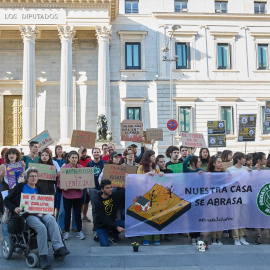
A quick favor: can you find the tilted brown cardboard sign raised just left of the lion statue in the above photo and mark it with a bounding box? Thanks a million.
[71,130,97,149]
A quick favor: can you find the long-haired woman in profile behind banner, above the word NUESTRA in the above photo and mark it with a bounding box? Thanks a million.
[207,156,225,245]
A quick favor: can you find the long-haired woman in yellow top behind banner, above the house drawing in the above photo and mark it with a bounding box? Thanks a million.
[137,150,164,246]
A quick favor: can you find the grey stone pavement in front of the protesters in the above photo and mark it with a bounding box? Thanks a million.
[0,210,270,270]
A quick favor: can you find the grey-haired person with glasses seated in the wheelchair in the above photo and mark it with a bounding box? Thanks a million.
[4,167,70,269]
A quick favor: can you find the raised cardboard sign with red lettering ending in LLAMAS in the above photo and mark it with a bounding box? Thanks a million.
[121,120,143,142]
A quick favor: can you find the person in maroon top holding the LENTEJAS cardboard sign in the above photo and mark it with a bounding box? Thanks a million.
[58,151,85,240]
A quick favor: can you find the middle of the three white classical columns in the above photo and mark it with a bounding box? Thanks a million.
[58,26,75,145]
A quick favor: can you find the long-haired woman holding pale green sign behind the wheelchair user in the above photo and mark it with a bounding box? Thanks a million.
[38,148,56,195]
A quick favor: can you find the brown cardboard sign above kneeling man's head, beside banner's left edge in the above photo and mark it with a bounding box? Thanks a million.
[102,164,138,187]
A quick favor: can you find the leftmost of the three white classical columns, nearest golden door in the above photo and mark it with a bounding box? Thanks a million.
[20,25,37,145]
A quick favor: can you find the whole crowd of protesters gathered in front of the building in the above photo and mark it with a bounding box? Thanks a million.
[0,141,270,266]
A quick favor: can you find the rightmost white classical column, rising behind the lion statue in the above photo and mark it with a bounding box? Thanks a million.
[96,26,111,130]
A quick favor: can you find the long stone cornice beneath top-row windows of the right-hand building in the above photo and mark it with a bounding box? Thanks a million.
[152,12,270,21]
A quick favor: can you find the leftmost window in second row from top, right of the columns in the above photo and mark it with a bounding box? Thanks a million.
[125,42,141,69]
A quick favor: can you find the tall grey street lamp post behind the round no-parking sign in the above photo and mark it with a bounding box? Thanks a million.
[162,24,181,145]
